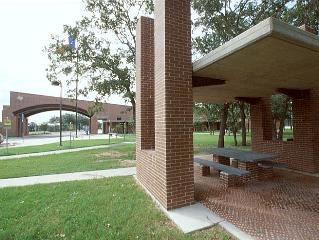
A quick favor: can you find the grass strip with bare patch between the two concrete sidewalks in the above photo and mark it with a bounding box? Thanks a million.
[0,144,135,179]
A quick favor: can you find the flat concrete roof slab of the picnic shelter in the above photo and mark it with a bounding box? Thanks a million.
[193,18,319,103]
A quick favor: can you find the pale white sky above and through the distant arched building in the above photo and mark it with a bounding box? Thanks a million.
[0,0,125,123]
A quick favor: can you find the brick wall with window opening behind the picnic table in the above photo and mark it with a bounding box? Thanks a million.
[251,89,319,173]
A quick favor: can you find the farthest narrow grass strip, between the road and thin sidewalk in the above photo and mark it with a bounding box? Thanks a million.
[0,135,135,156]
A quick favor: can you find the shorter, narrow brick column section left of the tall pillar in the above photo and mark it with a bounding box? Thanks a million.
[136,17,155,150]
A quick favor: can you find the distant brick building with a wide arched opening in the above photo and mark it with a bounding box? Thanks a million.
[2,92,133,137]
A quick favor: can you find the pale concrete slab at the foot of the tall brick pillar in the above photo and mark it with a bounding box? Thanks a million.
[165,203,223,233]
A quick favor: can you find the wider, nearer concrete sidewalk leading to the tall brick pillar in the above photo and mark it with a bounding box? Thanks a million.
[0,167,136,188]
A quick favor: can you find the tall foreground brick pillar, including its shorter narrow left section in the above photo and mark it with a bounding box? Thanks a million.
[136,0,194,209]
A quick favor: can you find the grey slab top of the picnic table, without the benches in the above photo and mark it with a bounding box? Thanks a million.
[209,148,276,162]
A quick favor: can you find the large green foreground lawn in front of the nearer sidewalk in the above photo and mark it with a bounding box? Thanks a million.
[0,177,230,240]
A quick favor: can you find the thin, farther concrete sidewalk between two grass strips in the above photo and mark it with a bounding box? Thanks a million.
[0,142,135,161]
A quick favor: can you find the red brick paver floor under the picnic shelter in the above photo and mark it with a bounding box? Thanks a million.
[195,169,319,240]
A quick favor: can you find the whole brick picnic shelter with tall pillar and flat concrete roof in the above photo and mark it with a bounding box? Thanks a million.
[136,0,319,209]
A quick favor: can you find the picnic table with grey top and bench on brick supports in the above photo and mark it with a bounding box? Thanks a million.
[194,148,276,187]
